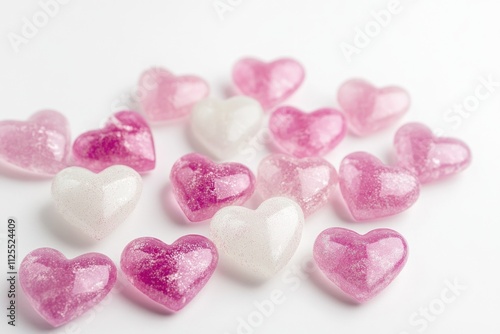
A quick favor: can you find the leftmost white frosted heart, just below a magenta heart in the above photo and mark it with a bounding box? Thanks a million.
[52,165,142,240]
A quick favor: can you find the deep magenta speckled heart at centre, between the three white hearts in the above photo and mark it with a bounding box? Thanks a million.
[170,153,255,222]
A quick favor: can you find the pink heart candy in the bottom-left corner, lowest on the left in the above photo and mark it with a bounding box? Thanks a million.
[19,248,116,327]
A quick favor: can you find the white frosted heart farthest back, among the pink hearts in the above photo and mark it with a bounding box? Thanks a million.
[191,96,264,160]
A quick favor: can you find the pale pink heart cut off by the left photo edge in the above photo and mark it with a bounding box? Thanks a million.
[0,110,71,176]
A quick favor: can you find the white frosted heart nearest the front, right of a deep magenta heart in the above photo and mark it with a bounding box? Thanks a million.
[210,197,304,279]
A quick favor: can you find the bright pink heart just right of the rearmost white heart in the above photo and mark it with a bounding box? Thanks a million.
[269,107,347,158]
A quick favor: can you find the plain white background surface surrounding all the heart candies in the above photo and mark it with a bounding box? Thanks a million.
[0,0,500,334]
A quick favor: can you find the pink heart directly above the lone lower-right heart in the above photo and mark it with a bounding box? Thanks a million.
[339,152,420,221]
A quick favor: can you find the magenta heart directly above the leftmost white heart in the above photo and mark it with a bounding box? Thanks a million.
[73,111,156,173]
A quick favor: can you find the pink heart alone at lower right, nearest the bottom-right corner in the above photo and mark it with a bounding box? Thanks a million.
[313,227,408,302]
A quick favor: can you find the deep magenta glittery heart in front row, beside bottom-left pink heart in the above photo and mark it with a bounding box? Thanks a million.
[120,235,219,312]
